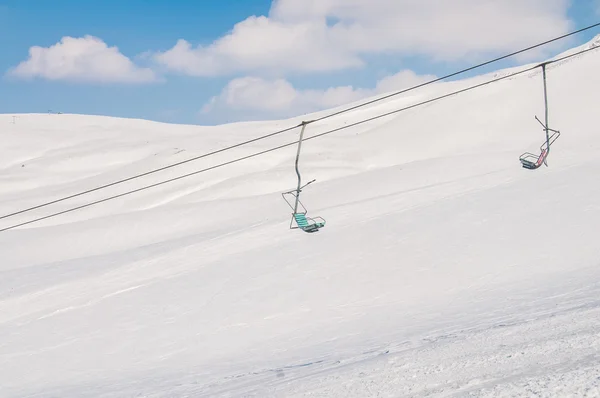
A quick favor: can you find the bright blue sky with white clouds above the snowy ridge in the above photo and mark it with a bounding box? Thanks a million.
[0,0,600,124]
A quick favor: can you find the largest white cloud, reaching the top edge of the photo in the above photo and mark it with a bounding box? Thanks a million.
[155,0,570,76]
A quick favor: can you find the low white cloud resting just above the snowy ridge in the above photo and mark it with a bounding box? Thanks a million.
[202,70,435,117]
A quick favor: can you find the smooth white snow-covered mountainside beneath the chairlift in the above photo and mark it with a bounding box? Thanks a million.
[0,40,600,397]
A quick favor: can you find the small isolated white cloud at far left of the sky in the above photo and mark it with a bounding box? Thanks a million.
[8,36,156,83]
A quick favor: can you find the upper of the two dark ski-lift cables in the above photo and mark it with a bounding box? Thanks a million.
[0,22,600,221]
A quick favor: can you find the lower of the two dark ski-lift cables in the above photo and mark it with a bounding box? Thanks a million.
[0,46,600,232]
